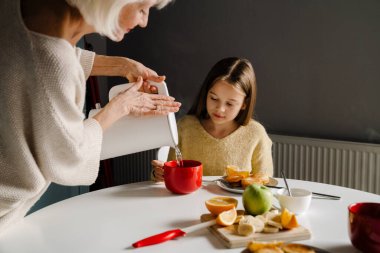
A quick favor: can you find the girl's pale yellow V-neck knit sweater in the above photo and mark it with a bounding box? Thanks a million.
[168,115,273,176]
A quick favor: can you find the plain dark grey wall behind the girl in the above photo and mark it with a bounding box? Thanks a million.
[107,0,380,143]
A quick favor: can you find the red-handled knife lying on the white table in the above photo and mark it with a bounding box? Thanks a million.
[132,220,216,248]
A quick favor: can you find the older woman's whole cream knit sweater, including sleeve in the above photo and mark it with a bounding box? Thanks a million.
[0,0,102,233]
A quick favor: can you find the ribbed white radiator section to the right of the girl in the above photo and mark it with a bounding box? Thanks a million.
[270,135,380,194]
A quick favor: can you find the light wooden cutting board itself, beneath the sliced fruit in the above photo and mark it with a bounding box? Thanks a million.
[201,212,311,248]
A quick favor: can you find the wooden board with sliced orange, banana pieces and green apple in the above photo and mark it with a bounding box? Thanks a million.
[201,196,311,249]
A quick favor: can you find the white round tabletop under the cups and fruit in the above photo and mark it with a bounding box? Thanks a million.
[0,177,380,253]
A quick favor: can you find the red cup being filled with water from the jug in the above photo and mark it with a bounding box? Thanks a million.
[164,160,203,194]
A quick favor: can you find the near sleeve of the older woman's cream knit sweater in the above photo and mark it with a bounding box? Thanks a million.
[32,51,103,185]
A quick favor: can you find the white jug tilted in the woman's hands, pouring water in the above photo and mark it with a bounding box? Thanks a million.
[89,82,178,160]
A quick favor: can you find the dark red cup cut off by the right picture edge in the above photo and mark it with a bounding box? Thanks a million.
[348,202,380,252]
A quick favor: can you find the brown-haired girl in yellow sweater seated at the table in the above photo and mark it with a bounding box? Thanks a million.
[152,57,273,181]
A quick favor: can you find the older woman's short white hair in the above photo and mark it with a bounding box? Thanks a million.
[66,0,172,41]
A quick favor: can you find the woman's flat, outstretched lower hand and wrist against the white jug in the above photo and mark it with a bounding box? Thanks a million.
[94,77,181,130]
